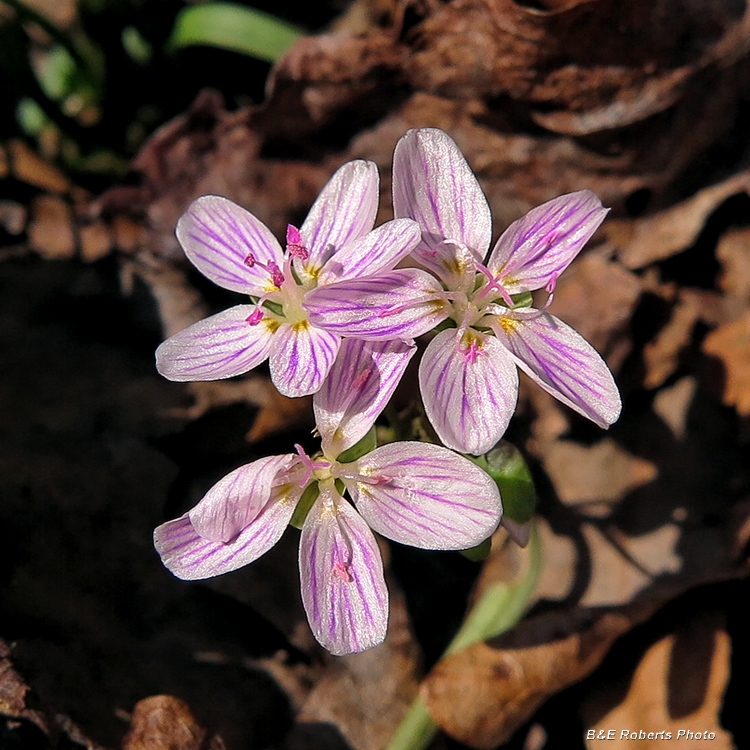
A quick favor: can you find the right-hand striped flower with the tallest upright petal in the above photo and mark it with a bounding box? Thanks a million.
[388,128,621,454]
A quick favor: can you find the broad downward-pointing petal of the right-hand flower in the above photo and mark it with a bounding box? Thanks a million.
[419,328,518,455]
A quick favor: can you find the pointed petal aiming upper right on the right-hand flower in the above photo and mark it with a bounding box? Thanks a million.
[487,190,609,294]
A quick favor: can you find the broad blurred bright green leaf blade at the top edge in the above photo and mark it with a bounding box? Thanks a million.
[169,3,304,62]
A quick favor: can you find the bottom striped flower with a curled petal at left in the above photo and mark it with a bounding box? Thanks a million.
[154,339,502,654]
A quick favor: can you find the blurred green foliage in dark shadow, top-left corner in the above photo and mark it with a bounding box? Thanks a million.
[0,0,339,190]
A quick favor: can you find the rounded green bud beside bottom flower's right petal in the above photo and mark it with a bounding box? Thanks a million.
[466,440,536,523]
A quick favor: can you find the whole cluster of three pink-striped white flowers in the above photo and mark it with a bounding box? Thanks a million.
[155,128,620,654]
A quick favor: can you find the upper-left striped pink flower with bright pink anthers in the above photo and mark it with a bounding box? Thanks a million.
[156,160,447,396]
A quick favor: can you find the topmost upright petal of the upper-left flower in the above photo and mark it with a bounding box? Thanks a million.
[302,159,380,275]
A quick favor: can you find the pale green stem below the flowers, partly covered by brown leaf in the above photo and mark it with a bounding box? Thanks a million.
[387,524,542,750]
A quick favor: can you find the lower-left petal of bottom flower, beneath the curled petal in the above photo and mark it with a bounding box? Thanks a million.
[154,476,302,581]
